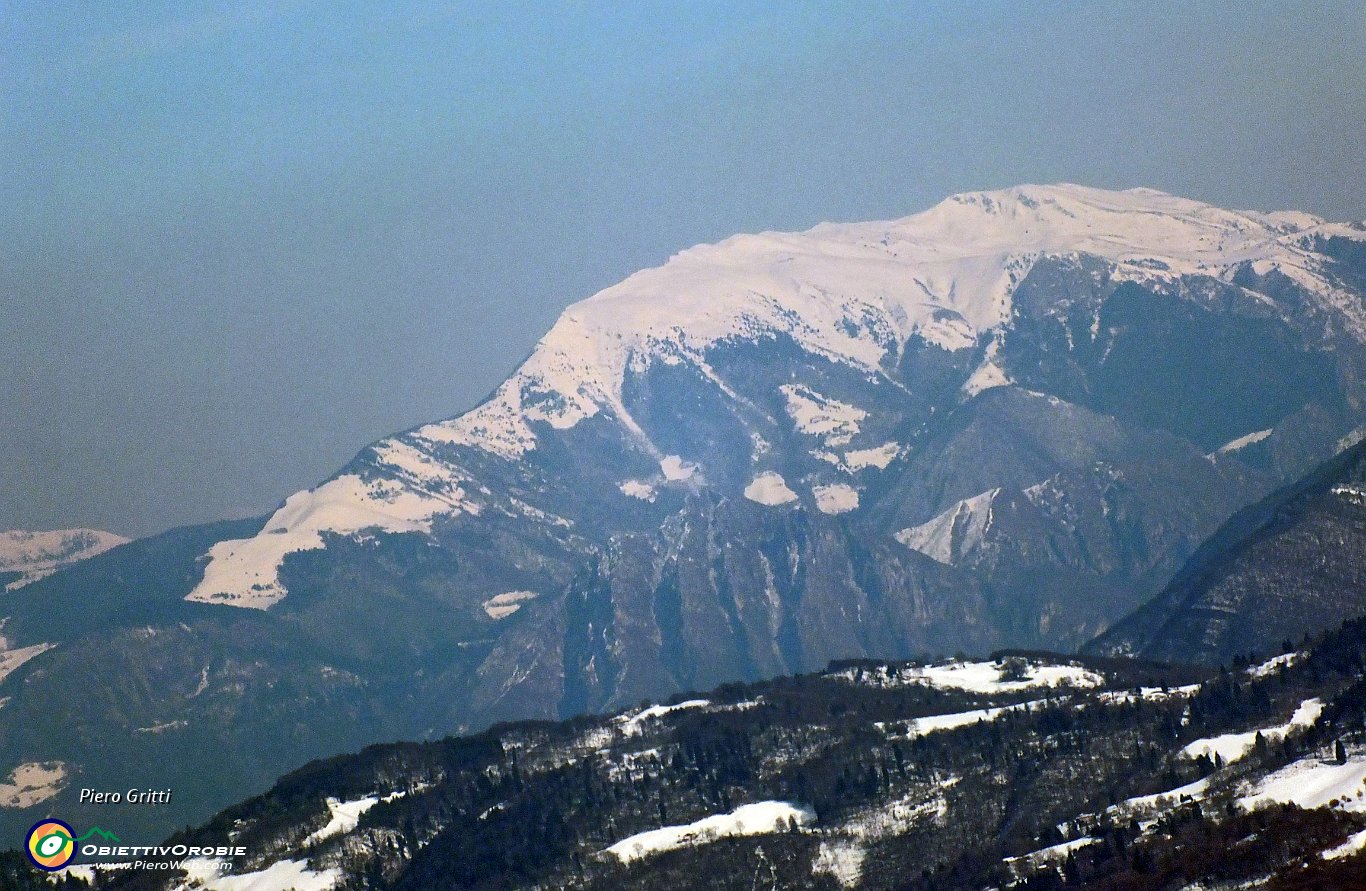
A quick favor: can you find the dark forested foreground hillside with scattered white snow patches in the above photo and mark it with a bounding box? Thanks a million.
[56,622,1366,891]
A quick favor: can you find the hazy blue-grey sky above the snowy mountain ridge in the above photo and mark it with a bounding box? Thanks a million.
[0,0,1366,534]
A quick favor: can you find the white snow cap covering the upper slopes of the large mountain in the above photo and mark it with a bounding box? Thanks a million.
[190,180,1366,608]
